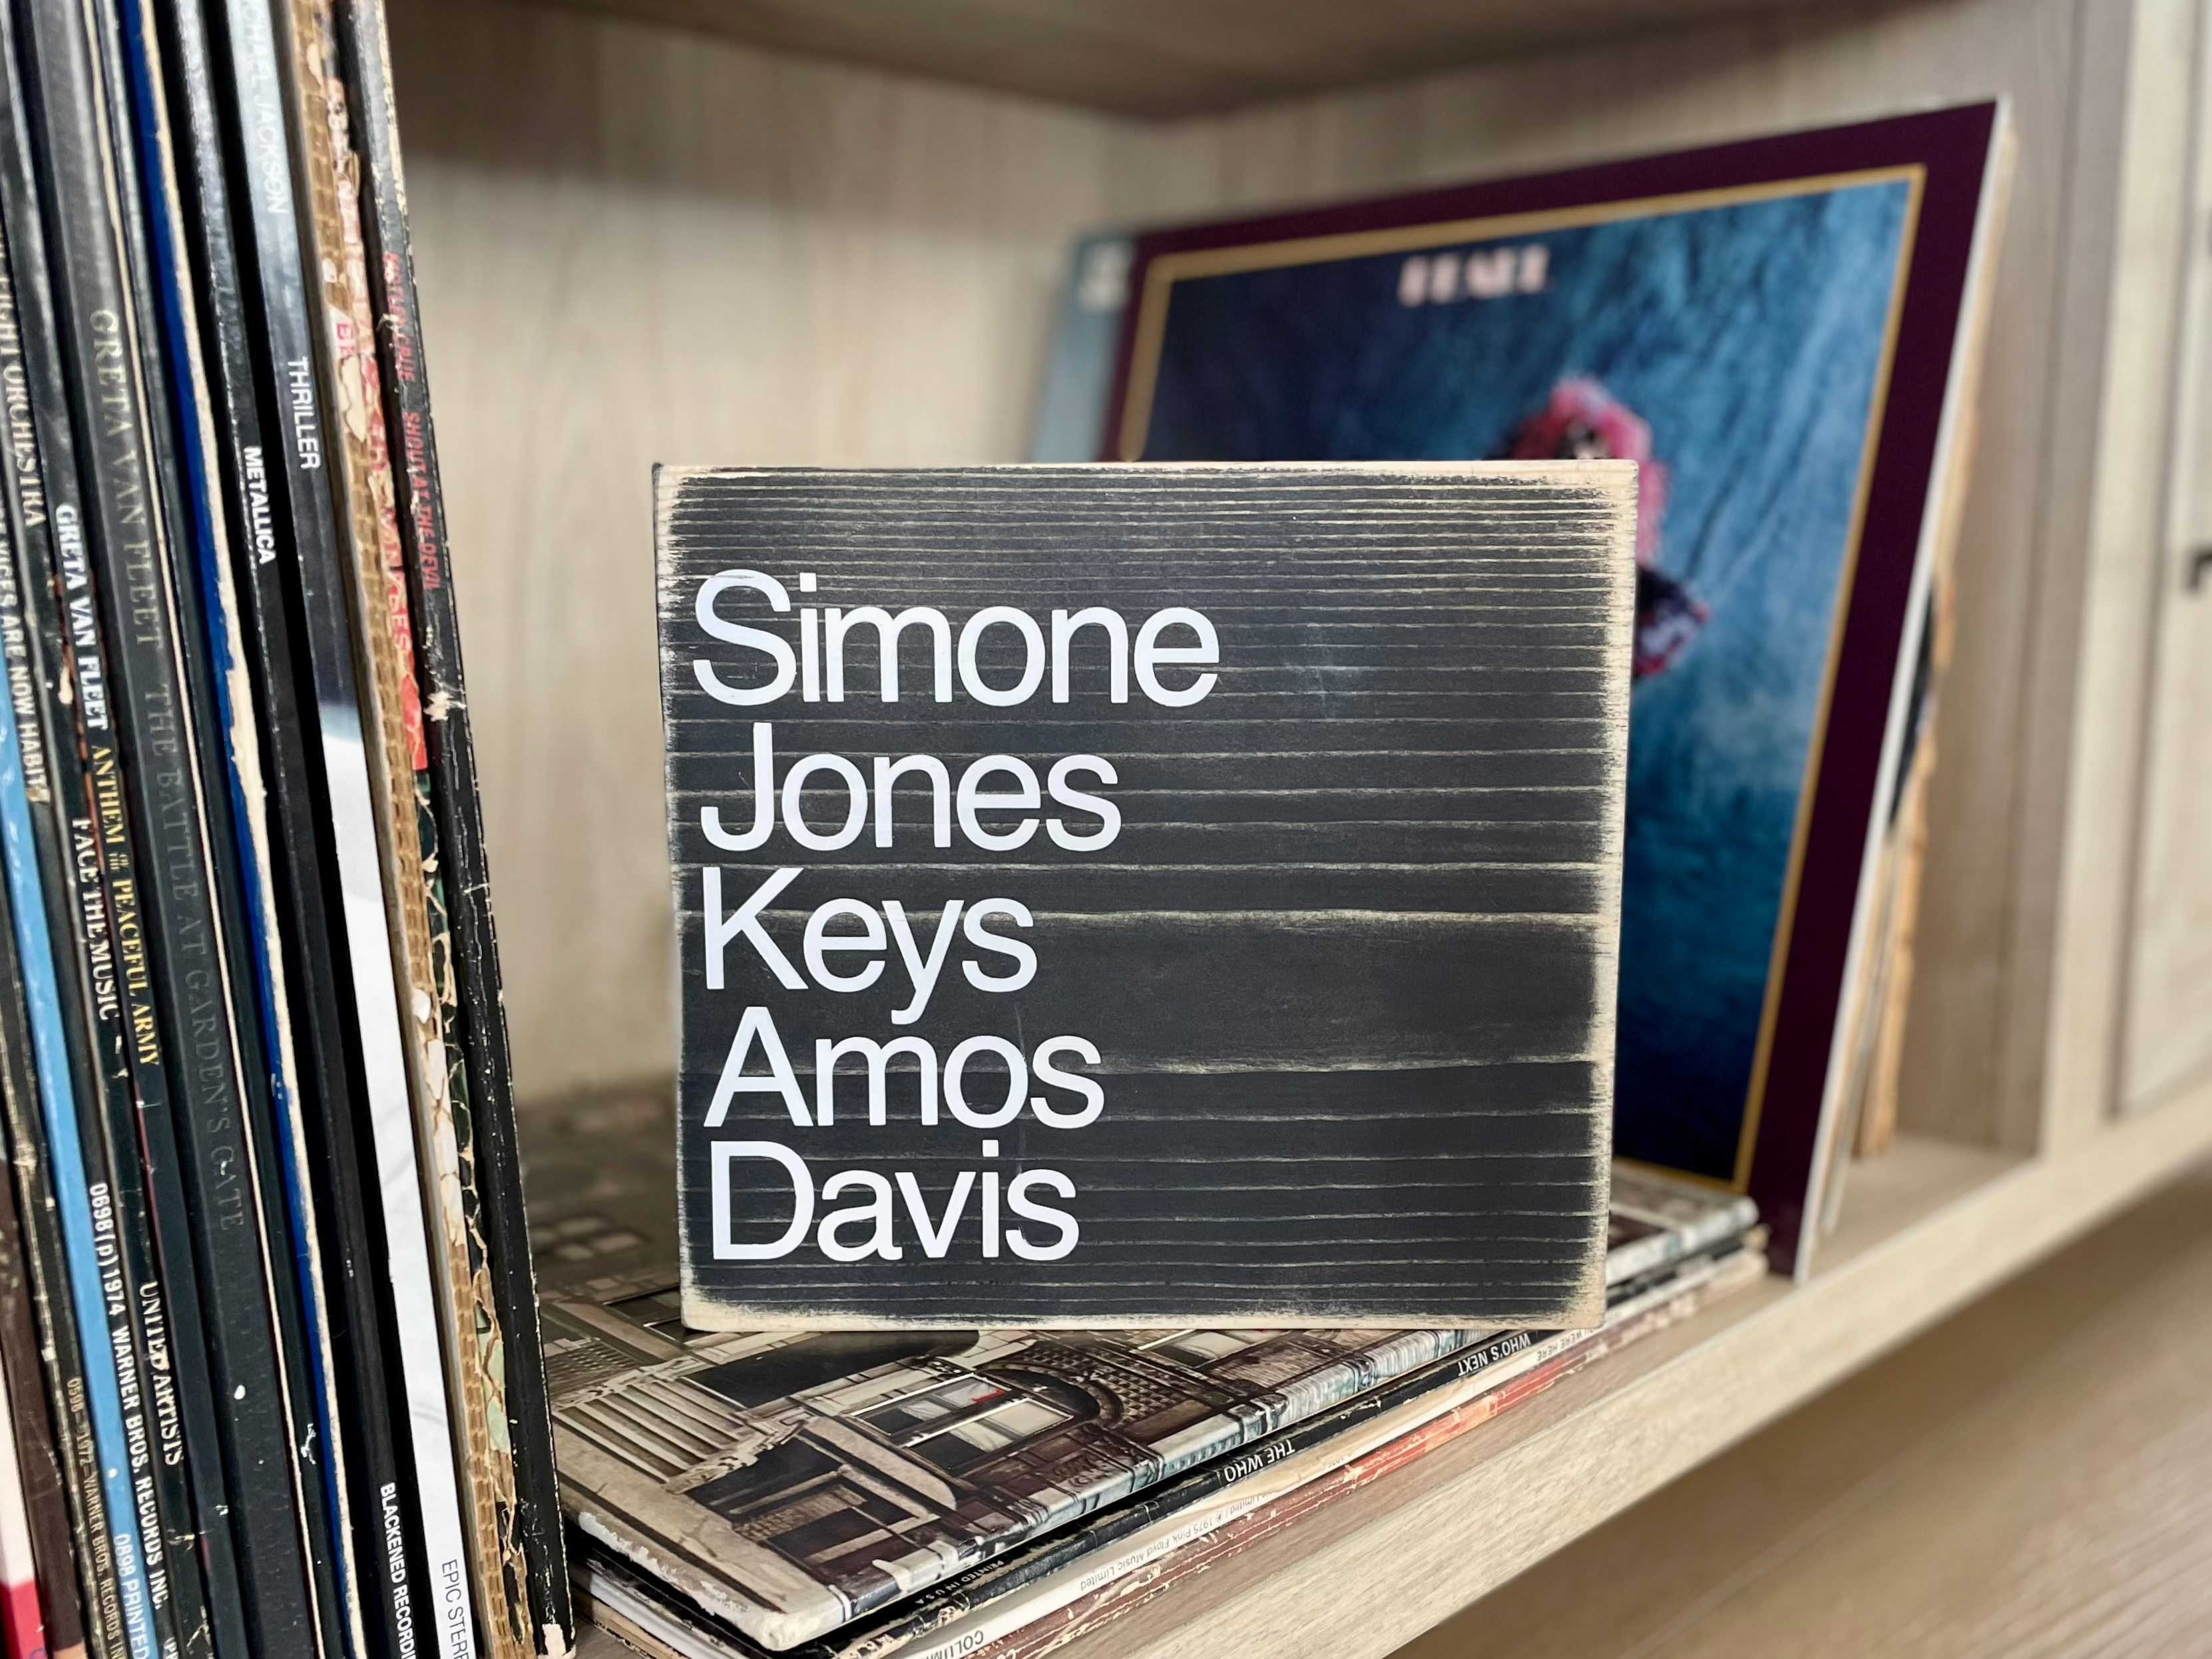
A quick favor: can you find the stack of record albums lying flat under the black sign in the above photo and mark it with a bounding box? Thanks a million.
[525,1093,1767,1659]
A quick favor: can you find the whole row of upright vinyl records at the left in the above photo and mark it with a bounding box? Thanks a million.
[0,0,573,1659]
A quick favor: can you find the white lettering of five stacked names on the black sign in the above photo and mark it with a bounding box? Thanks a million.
[690,571,1221,1263]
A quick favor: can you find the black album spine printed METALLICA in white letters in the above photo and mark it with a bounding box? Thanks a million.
[152,0,444,1657]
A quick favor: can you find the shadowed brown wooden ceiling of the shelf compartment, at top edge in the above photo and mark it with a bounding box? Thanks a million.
[509,0,1836,117]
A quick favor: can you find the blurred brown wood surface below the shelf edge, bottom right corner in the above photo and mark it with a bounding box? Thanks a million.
[1393,1163,2212,1659]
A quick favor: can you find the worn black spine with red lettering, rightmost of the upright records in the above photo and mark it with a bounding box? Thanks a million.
[338,0,575,1657]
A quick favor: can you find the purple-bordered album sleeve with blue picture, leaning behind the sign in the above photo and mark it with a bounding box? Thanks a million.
[1040,102,2008,1270]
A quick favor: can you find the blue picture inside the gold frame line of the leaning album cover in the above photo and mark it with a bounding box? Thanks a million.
[1100,179,1920,1186]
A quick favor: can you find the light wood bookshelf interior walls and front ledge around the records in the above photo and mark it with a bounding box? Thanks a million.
[375,0,2212,1657]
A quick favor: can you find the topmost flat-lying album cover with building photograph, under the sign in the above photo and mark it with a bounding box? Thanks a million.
[522,1091,1756,1659]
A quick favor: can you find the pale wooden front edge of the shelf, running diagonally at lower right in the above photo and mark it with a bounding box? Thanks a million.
[1062,1086,2212,1659]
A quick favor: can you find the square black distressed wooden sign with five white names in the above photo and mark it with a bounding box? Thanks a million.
[657,462,1635,1330]
